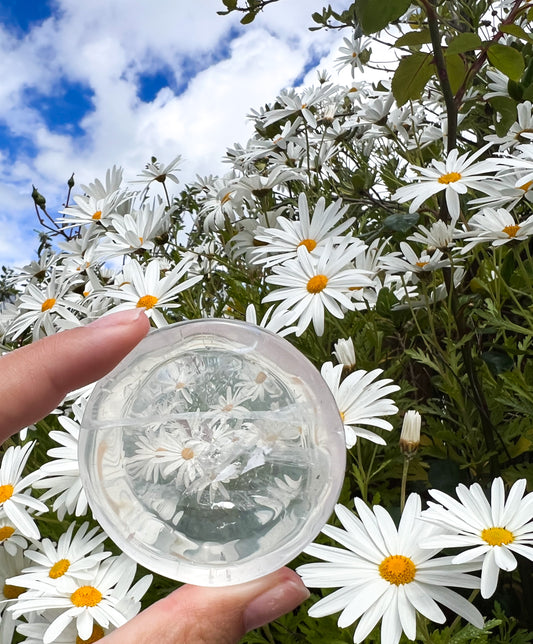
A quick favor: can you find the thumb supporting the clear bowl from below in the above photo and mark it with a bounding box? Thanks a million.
[102,568,309,644]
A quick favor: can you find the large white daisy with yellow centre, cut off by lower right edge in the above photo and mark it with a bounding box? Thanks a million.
[422,477,533,598]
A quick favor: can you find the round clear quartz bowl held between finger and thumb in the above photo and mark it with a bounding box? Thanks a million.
[79,319,346,586]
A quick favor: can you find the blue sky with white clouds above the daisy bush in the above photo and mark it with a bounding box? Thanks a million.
[0,0,350,266]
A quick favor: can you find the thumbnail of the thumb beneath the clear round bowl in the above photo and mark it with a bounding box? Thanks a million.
[243,579,310,632]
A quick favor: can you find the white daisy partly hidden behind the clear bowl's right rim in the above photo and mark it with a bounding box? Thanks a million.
[320,362,400,449]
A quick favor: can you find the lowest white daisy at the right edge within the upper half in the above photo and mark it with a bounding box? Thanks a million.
[461,208,533,254]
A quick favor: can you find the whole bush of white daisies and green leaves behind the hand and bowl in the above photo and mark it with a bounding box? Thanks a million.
[0,0,533,644]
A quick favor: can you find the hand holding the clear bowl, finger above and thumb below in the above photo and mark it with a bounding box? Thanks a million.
[0,309,309,644]
